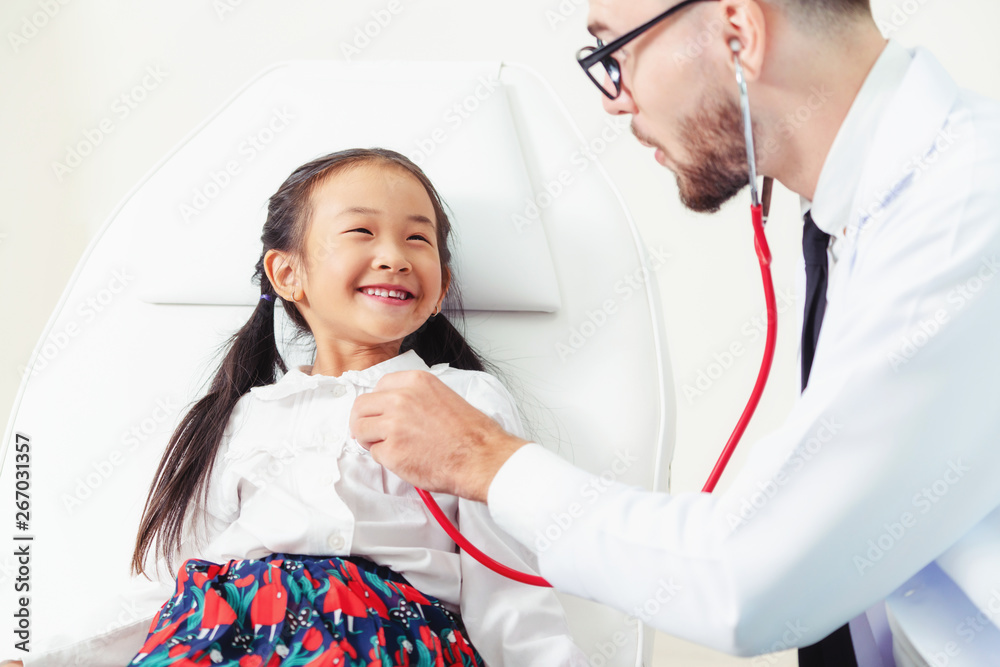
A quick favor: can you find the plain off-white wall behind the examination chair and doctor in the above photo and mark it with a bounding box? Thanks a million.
[0,0,1000,665]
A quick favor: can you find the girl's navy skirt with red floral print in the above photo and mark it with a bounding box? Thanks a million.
[129,554,484,667]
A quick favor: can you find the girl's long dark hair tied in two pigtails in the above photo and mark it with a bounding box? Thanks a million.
[132,148,485,573]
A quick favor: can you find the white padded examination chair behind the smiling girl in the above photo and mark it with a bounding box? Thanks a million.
[0,62,674,667]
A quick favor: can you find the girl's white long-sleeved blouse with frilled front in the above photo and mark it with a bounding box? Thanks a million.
[25,351,586,667]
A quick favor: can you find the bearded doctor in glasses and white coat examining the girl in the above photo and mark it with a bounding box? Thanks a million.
[351,0,1000,667]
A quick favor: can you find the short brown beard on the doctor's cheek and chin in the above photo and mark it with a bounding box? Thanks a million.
[648,93,750,213]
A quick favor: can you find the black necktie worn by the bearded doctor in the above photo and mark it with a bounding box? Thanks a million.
[799,212,858,667]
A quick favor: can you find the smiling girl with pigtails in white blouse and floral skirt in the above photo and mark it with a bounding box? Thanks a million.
[13,149,586,667]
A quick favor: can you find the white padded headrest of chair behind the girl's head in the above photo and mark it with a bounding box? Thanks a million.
[131,62,560,312]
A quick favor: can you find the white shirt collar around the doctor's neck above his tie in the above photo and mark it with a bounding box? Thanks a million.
[801,40,913,240]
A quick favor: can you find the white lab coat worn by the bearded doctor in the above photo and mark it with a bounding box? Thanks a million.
[488,42,1000,666]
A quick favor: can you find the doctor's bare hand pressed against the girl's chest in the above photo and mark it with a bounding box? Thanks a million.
[350,371,528,502]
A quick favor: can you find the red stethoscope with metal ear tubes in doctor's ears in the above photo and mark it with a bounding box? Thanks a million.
[417,39,778,588]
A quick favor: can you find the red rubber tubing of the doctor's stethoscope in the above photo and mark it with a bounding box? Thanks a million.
[417,197,778,588]
